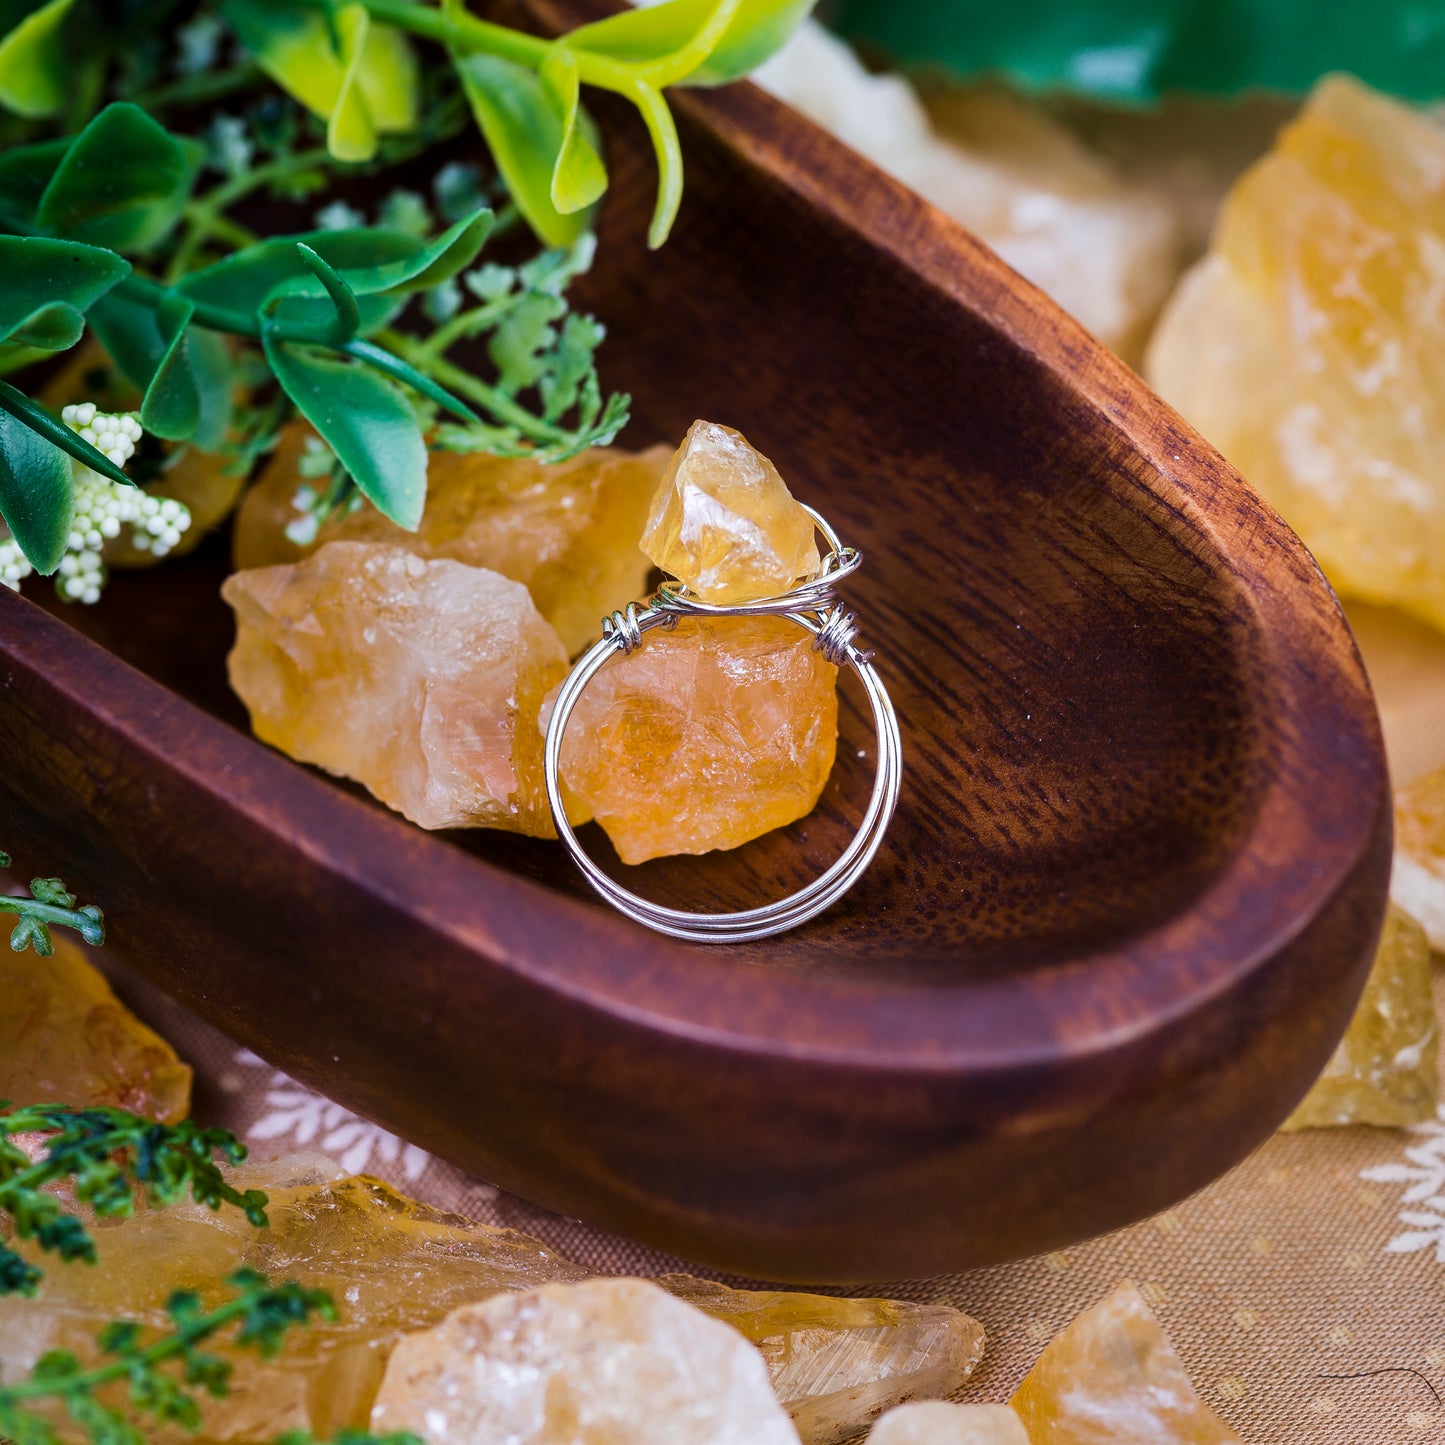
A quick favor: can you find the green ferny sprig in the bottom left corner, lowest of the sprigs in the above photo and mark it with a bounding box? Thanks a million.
[0,1269,332,1445]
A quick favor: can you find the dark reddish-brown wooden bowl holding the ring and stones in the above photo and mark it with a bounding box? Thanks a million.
[0,3,1390,1280]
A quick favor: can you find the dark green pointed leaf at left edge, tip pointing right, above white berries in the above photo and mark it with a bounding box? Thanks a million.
[0,236,130,351]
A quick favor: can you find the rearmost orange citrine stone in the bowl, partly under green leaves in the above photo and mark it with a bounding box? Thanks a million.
[234,423,669,653]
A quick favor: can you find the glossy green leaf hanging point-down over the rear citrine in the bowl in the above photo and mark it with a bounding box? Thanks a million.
[263,332,426,532]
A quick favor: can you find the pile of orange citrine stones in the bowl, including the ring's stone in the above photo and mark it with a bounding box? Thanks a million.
[223,422,838,863]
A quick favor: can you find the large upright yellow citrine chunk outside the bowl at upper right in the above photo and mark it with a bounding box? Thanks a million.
[1146,75,1445,627]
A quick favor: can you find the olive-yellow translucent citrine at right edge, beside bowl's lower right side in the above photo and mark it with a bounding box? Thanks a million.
[1283,905,1441,1129]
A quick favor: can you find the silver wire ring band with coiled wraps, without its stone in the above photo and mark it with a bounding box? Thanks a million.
[545,507,903,944]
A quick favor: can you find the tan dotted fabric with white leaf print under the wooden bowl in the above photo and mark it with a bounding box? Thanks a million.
[87,592,1445,1445]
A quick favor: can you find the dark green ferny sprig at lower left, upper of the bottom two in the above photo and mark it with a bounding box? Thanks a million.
[0,1104,267,1300]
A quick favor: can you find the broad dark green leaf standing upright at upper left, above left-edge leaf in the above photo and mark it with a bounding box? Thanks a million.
[38,101,199,251]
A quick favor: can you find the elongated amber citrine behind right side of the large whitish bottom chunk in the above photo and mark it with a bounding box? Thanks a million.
[657,1274,982,1445]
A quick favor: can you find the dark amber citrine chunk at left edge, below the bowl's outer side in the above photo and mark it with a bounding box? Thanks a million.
[0,929,191,1121]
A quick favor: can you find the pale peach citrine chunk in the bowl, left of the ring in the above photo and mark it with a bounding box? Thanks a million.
[221,542,566,837]
